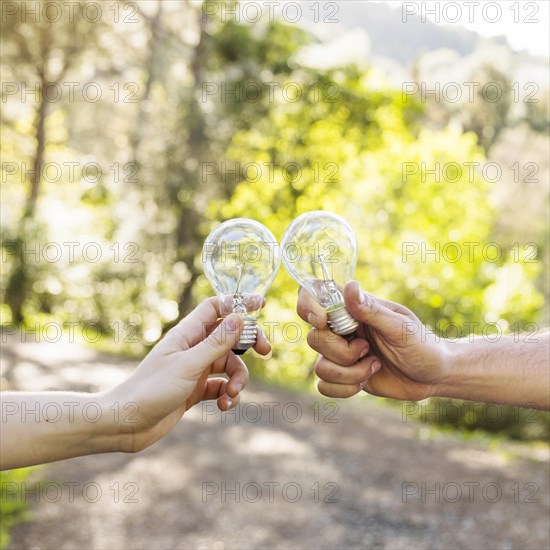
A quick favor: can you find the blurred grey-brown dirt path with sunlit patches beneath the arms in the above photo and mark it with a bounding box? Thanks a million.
[2,342,550,550]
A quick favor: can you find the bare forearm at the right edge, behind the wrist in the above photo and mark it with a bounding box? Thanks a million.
[436,332,550,410]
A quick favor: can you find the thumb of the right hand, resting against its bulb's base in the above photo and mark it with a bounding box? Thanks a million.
[344,281,403,335]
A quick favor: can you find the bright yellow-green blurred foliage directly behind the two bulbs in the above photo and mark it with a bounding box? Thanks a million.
[213,75,542,388]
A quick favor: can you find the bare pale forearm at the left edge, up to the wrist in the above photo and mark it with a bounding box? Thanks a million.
[0,392,125,470]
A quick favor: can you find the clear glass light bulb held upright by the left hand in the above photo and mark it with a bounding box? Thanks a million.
[202,218,281,355]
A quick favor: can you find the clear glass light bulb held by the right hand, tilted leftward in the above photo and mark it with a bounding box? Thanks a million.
[281,210,359,336]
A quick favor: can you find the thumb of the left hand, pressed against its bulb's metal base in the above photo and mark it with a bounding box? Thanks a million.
[184,313,243,376]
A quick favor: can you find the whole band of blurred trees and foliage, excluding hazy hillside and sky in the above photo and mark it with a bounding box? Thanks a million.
[0,2,548,444]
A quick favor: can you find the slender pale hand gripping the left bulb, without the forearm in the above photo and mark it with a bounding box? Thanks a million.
[109,298,271,451]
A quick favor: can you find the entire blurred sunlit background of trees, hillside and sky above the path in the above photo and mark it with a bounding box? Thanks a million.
[0,0,550,548]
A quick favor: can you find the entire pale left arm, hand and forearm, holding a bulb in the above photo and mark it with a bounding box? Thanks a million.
[0,298,271,469]
